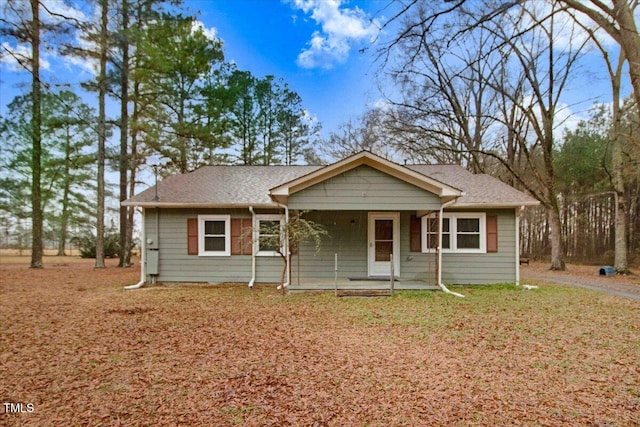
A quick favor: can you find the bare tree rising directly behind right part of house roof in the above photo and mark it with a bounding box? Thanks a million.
[382,6,502,172]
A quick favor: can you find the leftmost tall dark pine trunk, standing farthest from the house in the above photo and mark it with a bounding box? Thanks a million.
[30,0,44,268]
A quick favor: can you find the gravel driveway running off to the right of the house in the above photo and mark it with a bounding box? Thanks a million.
[520,268,640,300]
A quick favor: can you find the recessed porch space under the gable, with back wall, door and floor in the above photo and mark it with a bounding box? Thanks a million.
[287,210,441,291]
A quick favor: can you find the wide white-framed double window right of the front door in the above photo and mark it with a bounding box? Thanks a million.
[422,212,486,253]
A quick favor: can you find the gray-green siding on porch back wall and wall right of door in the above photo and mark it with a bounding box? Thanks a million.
[291,209,516,285]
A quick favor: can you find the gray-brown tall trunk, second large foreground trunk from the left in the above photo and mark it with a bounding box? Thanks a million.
[95,0,108,268]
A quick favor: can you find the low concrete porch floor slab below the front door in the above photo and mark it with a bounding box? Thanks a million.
[287,278,440,292]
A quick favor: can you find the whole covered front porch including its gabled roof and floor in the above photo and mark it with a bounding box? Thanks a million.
[269,152,462,289]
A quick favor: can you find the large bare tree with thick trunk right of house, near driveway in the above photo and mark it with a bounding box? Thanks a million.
[380,1,585,270]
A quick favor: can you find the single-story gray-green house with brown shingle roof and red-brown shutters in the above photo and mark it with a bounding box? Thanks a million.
[123,151,538,289]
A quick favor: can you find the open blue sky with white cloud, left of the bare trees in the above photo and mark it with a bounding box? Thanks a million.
[0,0,388,137]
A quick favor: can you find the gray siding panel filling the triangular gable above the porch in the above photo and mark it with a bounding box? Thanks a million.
[288,165,440,211]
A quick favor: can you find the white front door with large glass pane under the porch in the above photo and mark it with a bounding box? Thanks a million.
[368,212,400,277]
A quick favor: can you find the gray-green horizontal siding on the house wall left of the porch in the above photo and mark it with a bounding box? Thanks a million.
[145,209,283,283]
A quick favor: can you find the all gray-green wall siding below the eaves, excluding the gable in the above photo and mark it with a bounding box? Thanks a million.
[145,209,516,285]
